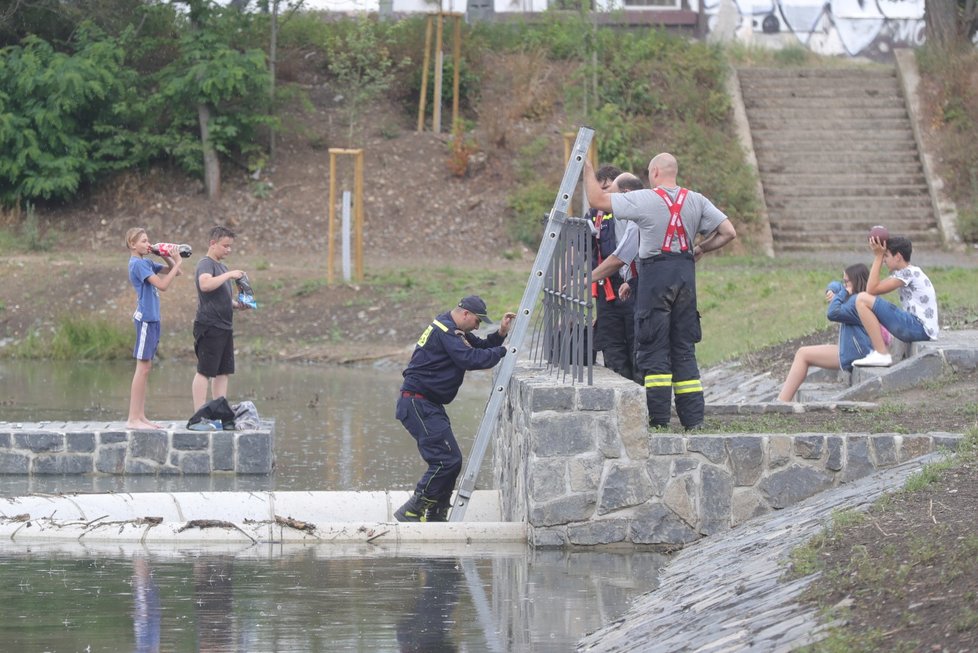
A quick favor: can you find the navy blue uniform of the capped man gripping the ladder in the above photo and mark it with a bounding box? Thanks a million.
[395,312,506,514]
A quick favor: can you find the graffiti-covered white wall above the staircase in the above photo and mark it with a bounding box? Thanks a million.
[704,0,924,58]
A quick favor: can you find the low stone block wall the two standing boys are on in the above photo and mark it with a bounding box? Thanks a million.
[0,420,275,475]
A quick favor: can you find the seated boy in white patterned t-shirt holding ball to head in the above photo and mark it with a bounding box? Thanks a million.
[852,236,940,367]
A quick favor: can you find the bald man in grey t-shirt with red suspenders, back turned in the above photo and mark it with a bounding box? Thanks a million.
[584,152,737,430]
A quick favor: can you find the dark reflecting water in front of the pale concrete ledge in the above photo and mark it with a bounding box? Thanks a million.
[0,547,665,653]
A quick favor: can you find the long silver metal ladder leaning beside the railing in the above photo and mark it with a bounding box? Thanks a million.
[449,127,594,521]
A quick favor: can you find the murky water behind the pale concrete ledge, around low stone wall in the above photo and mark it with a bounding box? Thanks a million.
[0,361,491,495]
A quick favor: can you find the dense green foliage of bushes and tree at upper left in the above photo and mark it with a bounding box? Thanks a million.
[0,0,276,206]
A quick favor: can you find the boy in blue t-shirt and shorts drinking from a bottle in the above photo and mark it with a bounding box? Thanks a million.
[126,227,183,429]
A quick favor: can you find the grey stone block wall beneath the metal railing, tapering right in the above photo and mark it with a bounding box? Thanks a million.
[493,368,960,546]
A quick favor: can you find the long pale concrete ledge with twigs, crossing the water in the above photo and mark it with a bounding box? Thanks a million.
[0,491,526,546]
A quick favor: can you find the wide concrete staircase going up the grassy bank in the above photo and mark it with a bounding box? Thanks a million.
[737,65,941,253]
